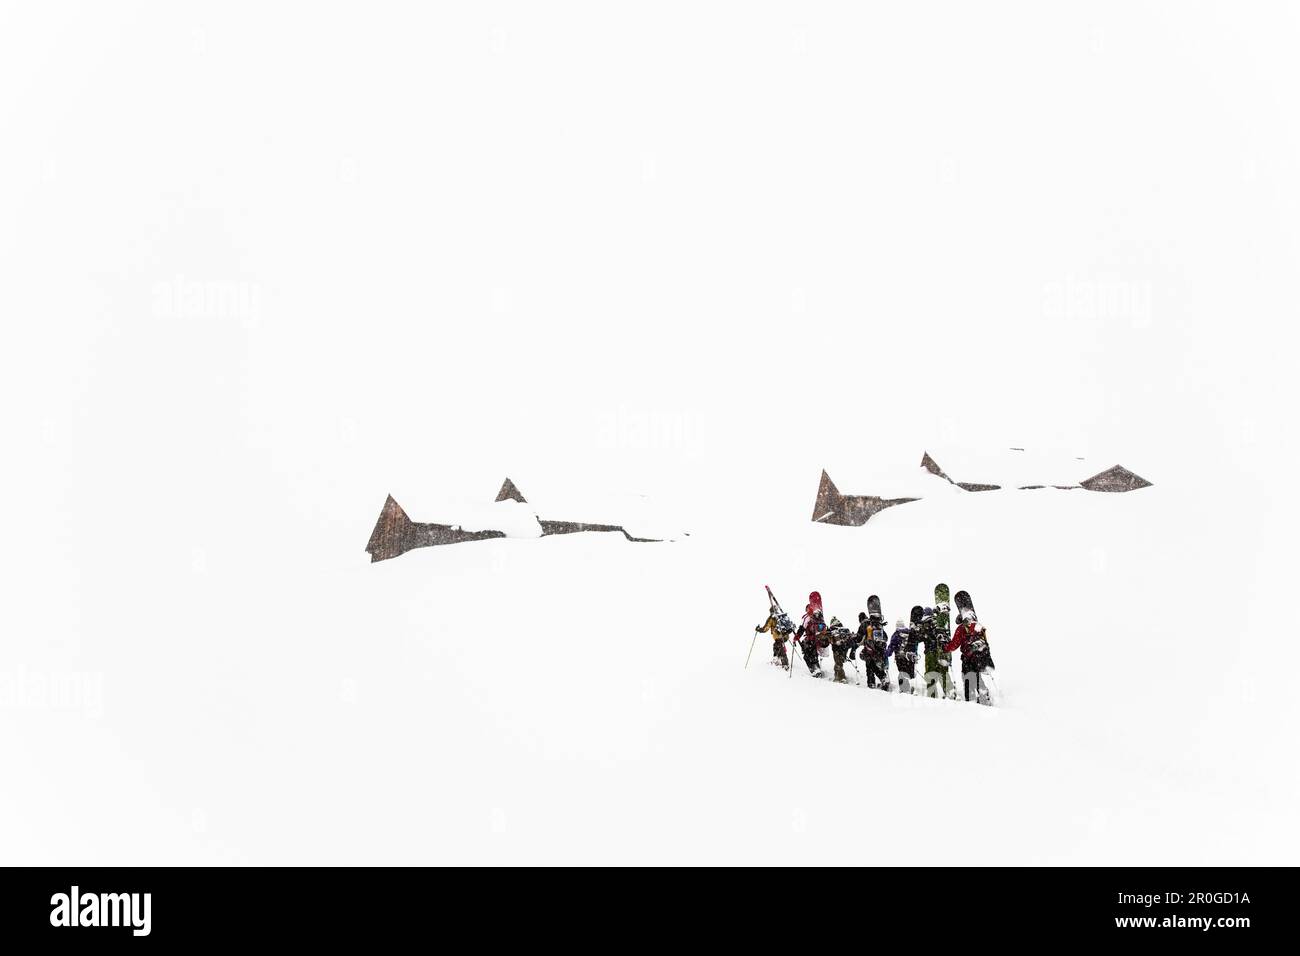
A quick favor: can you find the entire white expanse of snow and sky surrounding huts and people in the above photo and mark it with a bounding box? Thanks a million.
[0,1,1300,864]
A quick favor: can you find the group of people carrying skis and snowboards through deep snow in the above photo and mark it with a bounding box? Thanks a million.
[754,584,993,704]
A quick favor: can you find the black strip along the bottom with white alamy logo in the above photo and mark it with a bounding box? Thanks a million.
[0,868,1294,948]
